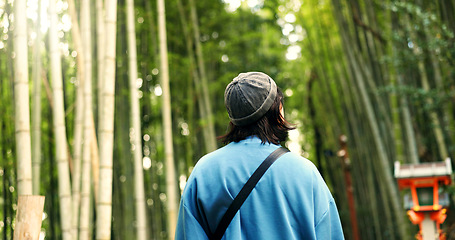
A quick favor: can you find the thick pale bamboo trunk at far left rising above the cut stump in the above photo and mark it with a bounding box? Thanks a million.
[14,0,32,195]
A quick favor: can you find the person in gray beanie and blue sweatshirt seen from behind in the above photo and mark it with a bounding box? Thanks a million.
[175,72,344,240]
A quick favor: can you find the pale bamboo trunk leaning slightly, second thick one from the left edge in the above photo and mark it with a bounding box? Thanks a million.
[49,0,72,240]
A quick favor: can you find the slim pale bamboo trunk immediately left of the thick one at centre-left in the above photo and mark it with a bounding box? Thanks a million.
[79,0,93,240]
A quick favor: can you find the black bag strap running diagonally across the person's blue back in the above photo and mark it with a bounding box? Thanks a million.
[210,147,289,240]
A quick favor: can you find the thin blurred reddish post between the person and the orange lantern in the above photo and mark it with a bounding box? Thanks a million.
[338,135,360,240]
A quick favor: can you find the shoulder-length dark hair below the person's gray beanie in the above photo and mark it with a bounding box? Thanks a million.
[218,88,295,144]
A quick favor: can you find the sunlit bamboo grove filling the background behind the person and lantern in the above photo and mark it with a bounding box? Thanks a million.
[0,0,455,240]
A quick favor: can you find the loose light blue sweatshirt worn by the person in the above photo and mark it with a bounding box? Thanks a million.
[175,137,344,240]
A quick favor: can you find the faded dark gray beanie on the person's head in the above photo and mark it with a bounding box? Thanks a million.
[224,72,277,126]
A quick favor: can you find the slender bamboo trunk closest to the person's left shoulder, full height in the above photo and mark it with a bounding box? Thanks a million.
[158,0,178,239]
